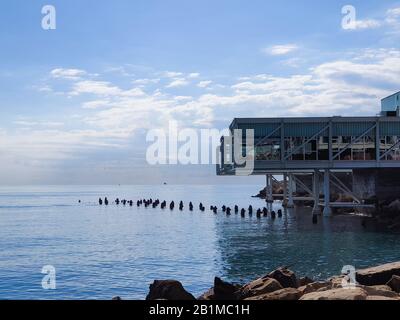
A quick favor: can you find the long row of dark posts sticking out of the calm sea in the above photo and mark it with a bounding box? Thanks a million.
[99,198,290,220]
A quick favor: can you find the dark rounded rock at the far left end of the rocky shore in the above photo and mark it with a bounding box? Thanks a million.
[146,280,196,301]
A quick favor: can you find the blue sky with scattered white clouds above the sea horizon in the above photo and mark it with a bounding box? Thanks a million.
[0,0,400,185]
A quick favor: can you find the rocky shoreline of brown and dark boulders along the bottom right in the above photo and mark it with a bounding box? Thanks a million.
[142,262,400,301]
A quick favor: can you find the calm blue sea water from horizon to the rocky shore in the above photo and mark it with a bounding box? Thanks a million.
[0,185,400,299]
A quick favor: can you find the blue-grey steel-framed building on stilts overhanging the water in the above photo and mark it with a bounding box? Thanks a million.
[217,92,400,215]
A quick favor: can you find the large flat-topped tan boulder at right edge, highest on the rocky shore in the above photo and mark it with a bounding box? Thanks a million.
[356,262,400,286]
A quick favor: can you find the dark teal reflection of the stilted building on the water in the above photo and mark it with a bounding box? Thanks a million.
[216,208,400,282]
